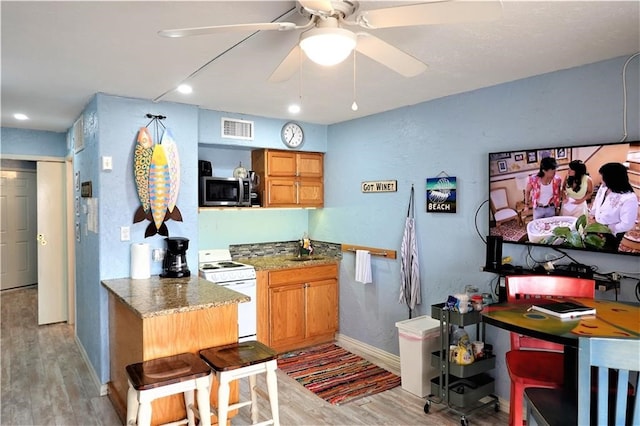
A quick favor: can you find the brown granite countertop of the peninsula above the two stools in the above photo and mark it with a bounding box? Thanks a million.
[102,274,251,318]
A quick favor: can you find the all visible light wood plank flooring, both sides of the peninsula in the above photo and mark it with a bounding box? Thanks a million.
[0,287,507,426]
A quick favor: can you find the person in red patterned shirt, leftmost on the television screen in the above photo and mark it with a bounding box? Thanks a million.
[525,157,562,220]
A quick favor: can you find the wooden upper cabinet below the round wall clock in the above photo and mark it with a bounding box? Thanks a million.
[251,149,324,207]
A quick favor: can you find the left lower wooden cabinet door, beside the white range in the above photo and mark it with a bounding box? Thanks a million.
[269,284,305,348]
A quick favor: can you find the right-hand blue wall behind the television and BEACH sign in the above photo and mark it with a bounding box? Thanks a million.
[309,58,640,397]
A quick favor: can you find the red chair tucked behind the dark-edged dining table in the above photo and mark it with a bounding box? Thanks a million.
[505,275,595,426]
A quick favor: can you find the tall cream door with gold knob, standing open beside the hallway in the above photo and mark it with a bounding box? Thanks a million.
[36,161,68,325]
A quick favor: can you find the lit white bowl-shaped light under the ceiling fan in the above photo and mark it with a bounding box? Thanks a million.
[300,28,357,66]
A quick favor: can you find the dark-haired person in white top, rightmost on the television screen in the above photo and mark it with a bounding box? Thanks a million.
[591,163,638,251]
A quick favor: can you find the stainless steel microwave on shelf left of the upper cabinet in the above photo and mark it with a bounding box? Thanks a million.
[198,176,251,207]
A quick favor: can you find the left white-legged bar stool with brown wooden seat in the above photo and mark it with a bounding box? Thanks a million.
[126,353,213,426]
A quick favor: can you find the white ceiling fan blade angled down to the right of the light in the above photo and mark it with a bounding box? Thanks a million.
[356,32,427,77]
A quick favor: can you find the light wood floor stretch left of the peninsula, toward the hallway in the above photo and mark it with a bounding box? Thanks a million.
[0,287,120,425]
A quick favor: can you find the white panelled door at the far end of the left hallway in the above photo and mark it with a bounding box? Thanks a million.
[0,170,38,290]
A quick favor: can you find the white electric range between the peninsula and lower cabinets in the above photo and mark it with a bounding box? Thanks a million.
[198,249,257,342]
